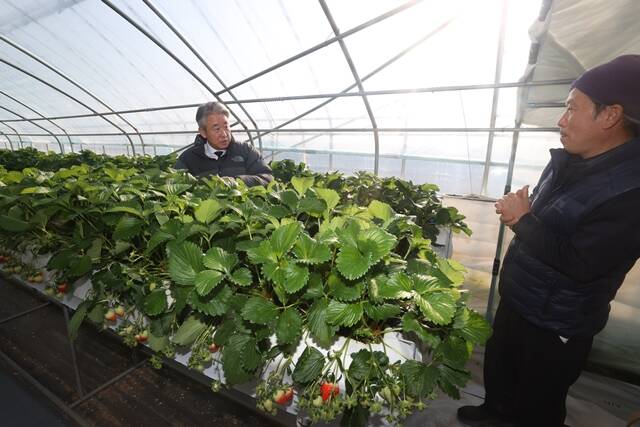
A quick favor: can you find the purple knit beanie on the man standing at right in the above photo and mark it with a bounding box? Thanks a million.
[571,55,640,123]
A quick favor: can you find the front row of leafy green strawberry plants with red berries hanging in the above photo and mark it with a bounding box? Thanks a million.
[0,155,489,425]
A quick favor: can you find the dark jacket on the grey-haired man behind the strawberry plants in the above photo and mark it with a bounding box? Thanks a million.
[174,135,273,186]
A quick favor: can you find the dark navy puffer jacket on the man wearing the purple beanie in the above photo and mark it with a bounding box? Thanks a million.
[500,139,640,337]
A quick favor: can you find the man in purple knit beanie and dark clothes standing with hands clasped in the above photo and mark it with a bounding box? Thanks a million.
[458,55,640,427]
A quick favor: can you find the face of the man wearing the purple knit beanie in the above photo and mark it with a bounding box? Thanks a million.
[558,88,605,159]
